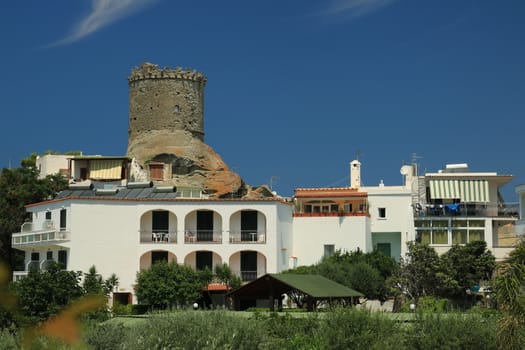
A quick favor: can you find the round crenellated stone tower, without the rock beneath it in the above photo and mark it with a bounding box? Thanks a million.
[128,63,207,153]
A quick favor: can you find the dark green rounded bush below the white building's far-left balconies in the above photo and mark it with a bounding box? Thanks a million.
[12,262,84,321]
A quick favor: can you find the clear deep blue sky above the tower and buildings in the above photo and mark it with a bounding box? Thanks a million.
[0,0,525,202]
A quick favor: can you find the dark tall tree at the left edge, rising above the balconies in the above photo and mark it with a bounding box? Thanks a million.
[0,158,67,270]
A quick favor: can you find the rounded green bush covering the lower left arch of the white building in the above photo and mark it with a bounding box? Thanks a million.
[135,262,211,309]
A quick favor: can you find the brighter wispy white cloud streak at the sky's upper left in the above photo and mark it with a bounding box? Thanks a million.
[49,0,157,46]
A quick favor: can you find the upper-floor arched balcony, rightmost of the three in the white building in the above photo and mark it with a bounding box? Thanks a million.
[229,210,266,244]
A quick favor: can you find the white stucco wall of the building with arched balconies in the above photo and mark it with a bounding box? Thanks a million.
[21,199,292,300]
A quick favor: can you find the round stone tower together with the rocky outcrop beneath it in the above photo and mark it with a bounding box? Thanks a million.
[127,63,272,198]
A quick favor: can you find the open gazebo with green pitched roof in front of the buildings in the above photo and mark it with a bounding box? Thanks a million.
[226,273,364,311]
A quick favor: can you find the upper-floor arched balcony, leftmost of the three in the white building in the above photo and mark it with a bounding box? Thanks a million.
[140,209,177,244]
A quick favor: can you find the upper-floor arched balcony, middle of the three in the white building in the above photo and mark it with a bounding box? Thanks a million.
[184,210,222,244]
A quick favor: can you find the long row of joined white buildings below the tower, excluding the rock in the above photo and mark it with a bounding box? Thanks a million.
[12,156,521,301]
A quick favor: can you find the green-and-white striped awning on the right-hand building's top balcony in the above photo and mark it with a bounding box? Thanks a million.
[429,179,489,203]
